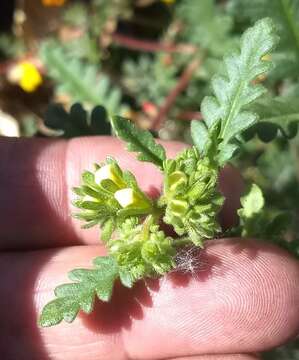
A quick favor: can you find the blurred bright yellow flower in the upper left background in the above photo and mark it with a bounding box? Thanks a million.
[8,61,43,92]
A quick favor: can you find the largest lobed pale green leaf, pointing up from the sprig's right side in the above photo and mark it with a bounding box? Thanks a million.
[197,18,278,165]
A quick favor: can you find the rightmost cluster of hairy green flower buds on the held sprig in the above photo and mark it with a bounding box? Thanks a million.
[160,147,223,246]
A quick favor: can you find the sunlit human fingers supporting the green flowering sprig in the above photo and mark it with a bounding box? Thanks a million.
[0,137,299,360]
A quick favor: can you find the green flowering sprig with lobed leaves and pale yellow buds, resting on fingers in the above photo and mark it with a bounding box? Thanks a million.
[39,18,290,326]
